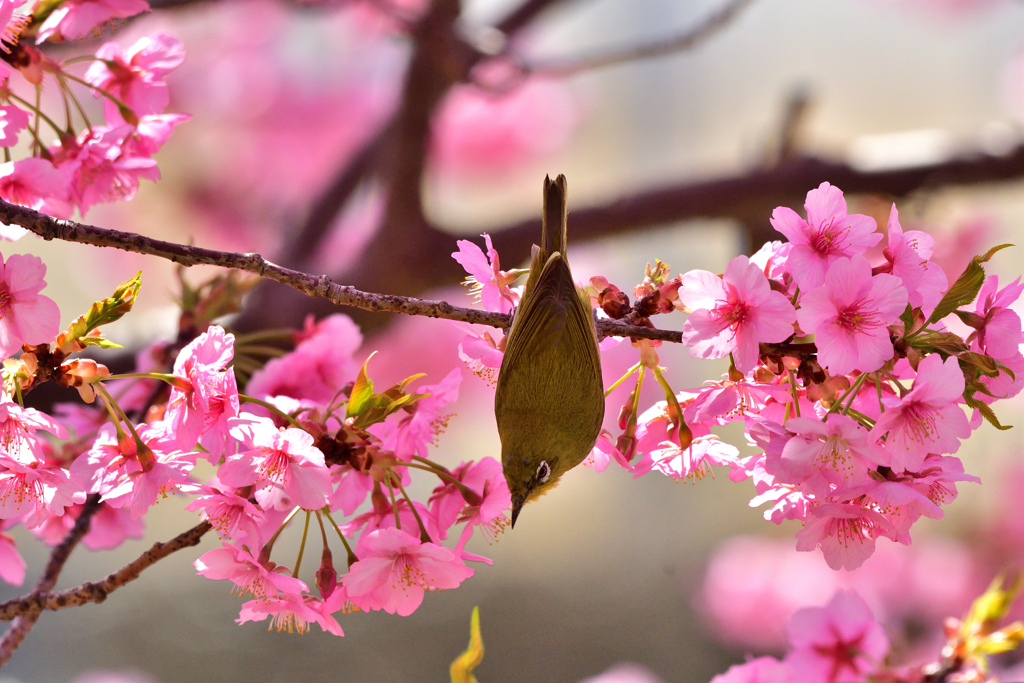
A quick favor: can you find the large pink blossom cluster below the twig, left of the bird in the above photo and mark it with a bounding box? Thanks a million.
[0,256,510,635]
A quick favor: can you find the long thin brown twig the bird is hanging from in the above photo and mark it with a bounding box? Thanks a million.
[8,200,682,342]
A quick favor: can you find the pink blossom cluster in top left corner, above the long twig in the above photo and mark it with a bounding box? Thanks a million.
[0,0,189,227]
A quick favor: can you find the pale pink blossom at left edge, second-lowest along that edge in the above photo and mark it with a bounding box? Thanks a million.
[0,453,85,528]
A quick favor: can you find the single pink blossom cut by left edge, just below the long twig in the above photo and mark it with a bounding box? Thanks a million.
[0,250,60,357]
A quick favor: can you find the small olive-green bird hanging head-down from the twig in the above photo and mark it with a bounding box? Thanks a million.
[495,175,604,526]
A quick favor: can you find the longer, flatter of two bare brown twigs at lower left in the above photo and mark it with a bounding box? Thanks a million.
[0,517,212,622]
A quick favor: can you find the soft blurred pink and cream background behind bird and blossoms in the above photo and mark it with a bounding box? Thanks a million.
[9,0,1024,683]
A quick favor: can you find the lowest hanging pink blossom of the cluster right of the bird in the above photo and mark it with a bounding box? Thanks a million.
[797,503,893,571]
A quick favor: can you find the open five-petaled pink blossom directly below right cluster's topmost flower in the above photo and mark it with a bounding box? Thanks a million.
[797,256,907,375]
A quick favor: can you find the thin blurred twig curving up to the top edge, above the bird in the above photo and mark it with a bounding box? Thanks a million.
[521,0,754,78]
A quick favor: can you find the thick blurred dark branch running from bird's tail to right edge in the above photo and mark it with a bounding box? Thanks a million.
[487,144,1024,263]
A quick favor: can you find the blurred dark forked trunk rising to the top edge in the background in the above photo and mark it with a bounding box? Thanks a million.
[238,0,585,330]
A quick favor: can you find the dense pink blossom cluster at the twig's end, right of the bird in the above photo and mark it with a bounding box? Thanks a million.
[456,183,1024,569]
